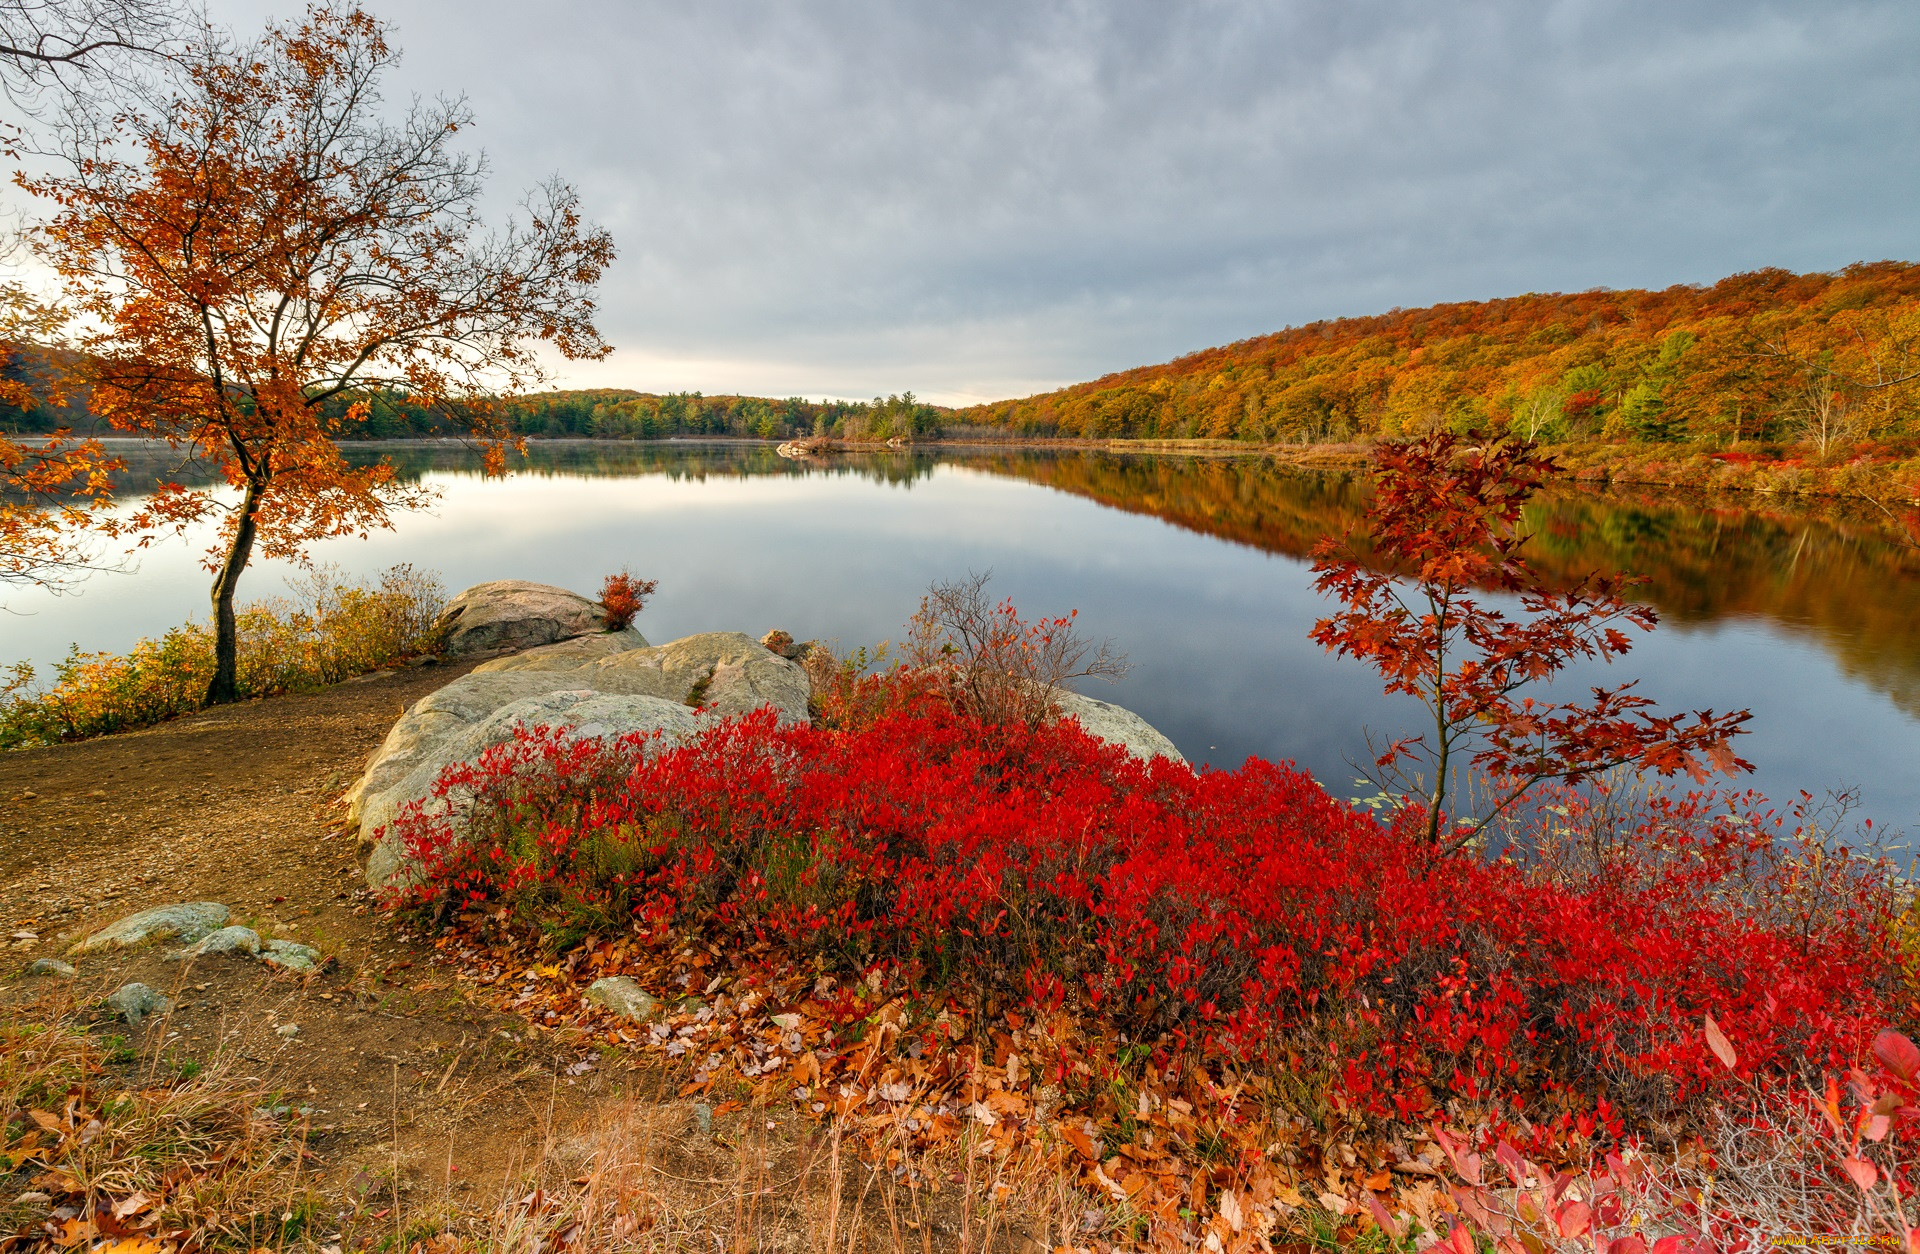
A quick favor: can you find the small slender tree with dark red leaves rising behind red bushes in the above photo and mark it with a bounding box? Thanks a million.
[1313,432,1751,853]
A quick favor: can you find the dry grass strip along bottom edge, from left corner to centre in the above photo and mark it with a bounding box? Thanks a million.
[0,999,1117,1254]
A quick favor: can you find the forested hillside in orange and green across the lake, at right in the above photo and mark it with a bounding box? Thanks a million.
[954,261,1920,453]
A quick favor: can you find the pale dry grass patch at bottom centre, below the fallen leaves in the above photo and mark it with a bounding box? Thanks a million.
[322,1075,1108,1254]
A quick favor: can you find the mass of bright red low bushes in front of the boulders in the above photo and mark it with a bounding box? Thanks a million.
[378,676,1891,1135]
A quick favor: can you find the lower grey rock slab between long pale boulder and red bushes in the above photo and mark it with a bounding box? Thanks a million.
[361,691,699,887]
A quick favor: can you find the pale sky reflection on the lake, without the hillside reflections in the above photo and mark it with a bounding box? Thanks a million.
[11,445,1920,830]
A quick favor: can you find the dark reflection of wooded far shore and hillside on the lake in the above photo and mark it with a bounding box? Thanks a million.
[86,440,1920,716]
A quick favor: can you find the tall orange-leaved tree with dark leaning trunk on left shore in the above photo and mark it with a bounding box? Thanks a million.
[25,6,612,703]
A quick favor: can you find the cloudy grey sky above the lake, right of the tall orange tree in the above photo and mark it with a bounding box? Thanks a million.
[168,0,1920,401]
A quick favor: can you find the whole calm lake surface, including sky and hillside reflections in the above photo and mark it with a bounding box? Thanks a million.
[0,442,1920,830]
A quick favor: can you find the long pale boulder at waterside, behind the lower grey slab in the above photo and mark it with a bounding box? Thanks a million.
[348,632,806,833]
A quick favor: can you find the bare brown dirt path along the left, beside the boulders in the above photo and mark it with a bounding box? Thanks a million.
[0,666,817,1236]
